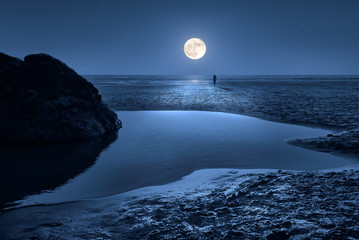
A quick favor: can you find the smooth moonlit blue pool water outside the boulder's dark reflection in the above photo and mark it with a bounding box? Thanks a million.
[9,111,354,206]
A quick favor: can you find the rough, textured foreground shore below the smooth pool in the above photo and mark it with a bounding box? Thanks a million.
[0,170,359,239]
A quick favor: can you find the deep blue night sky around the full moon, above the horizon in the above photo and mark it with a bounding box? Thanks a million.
[0,0,359,75]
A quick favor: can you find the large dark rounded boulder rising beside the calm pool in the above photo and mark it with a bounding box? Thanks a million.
[0,53,122,143]
